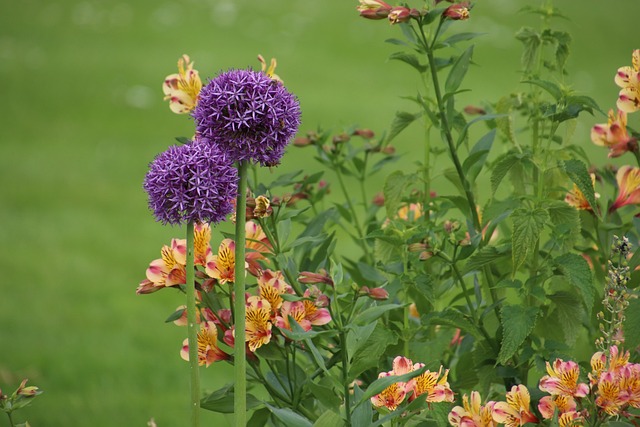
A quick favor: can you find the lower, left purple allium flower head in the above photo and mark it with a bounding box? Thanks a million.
[143,141,238,224]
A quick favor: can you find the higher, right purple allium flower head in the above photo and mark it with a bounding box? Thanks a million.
[192,70,300,166]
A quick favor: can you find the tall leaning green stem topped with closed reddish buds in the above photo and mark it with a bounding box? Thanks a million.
[419,25,481,239]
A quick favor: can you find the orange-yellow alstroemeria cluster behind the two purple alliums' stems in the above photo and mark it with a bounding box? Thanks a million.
[137,221,331,366]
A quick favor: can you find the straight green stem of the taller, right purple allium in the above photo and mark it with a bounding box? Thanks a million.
[233,161,247,427]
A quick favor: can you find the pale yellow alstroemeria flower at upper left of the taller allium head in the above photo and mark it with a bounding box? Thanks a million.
[162,55,202,114]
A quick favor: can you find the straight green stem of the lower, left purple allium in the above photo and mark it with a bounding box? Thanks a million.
[186,221,200,427]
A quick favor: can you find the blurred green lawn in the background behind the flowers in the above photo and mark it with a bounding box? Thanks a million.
[0,0,640,427]
